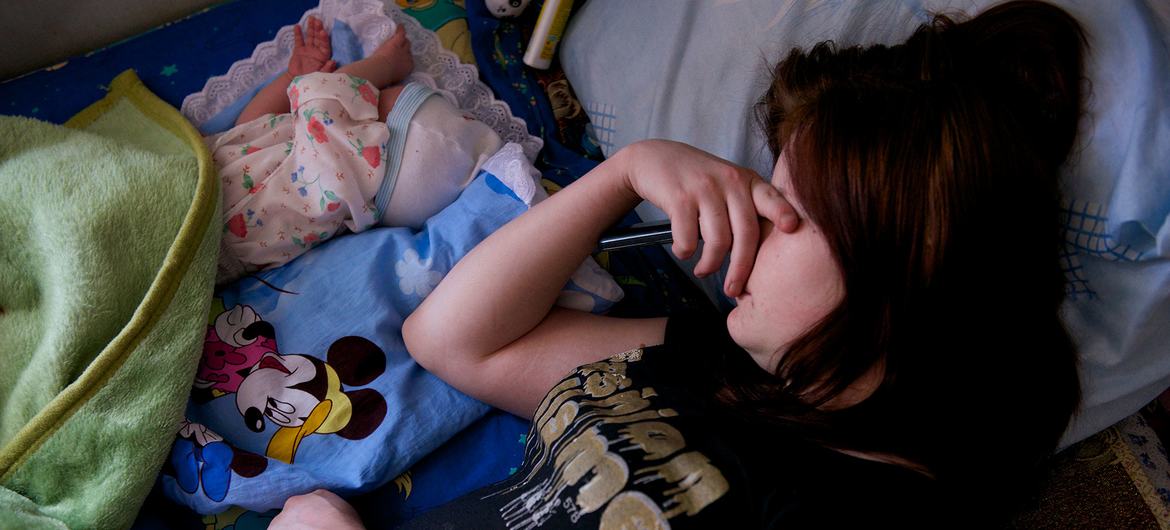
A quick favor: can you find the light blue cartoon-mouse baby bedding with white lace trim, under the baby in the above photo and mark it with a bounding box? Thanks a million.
[161,1,620,514]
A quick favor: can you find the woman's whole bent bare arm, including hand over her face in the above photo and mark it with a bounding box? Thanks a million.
[402,140,797,417]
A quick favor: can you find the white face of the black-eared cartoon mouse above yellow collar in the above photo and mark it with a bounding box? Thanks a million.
[235,352,322,433]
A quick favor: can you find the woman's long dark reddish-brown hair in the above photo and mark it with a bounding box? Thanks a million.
[739,1,1087,517]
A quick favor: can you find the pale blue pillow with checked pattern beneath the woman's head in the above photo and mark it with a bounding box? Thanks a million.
[560,0,1170,445]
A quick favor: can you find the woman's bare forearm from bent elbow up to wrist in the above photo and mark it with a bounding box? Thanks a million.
[402,152,640,357]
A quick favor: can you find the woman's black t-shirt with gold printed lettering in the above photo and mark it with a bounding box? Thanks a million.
[407,315,938,530]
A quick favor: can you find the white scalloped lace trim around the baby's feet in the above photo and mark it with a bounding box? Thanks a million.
[181,0,544,160]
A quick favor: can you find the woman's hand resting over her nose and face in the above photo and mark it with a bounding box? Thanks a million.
[613,140,800,297]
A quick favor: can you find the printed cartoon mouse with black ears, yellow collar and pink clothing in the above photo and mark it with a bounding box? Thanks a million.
[192,305,387,463]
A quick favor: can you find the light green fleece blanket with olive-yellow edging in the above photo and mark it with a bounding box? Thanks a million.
[0,70,220,529]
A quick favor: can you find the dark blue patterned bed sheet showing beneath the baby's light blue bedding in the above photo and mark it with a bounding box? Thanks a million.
[0,0,706,528]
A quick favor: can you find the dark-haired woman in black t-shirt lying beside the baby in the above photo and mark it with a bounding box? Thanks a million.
[273,1,1086,529]
